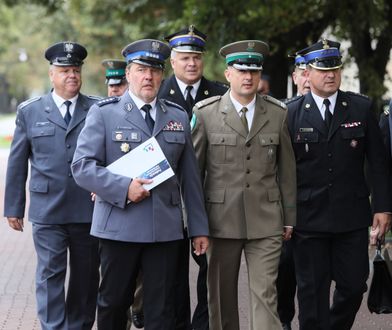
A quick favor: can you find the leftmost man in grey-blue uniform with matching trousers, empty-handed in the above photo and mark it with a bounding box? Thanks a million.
[4,41,99,330]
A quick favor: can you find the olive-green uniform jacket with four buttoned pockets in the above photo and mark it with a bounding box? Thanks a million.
[192,91,296,239]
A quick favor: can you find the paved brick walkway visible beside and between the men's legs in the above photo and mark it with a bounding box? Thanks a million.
[0,149,392,330]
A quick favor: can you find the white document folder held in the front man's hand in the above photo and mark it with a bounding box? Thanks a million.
[106,137,174,190]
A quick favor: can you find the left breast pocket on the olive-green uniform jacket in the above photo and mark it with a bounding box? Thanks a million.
[209,133,237,164]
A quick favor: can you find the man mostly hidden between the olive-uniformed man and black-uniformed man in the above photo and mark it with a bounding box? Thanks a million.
[276,55,310,330]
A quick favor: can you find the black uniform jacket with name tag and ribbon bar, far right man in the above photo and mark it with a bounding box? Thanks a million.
[287,91,391,233]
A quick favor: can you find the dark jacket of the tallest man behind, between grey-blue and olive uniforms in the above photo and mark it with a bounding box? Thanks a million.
[158,75,228,118]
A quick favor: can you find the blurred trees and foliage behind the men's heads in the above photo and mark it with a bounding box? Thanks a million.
[0,0,392,114]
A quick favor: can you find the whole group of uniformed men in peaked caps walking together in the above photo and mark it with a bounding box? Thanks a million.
[4,26,392,330]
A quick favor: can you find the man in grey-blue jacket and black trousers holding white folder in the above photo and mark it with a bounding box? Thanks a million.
[72,39,208,330]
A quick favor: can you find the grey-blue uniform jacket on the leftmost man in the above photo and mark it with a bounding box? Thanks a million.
[4,93,98,224]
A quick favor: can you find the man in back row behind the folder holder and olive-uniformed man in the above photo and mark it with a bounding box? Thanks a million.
[159,25,227,330]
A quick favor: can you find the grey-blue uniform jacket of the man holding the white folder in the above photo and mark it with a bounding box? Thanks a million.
[72,93,208,242]
